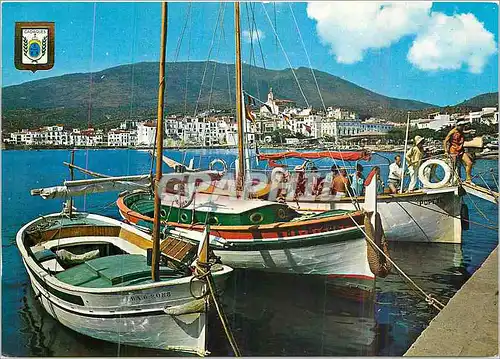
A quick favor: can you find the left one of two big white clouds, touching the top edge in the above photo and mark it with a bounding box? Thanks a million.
[307,1,432,64]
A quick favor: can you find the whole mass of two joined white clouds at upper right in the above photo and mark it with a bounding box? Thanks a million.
[307,1,496,73]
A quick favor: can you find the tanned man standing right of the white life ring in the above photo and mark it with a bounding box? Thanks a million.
[443,121,472,182]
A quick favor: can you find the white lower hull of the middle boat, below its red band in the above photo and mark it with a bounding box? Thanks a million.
[168,228,375,290]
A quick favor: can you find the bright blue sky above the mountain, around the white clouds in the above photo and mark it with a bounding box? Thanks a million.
[1,1,498,106]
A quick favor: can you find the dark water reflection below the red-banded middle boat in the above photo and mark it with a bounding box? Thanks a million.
[209,270,376,356]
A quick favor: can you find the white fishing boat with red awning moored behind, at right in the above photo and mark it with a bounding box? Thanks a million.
[250,151,468,243]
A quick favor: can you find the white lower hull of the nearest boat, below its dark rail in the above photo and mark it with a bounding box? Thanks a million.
[26,264,206,355]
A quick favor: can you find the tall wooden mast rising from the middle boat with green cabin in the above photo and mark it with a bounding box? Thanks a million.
[234,2,246,193]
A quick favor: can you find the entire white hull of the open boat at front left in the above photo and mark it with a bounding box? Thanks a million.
[17,215,232,356]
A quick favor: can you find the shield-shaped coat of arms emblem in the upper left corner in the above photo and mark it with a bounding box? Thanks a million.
[15,22,54,72]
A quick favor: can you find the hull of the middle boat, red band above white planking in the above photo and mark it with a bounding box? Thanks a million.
[117,194,375,286]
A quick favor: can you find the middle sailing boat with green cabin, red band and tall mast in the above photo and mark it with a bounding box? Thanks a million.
[117,2,390,289]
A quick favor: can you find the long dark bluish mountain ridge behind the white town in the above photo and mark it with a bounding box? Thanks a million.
[2,62,434,129]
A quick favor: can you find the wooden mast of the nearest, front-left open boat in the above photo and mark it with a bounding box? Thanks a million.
[151,2,167,282]
